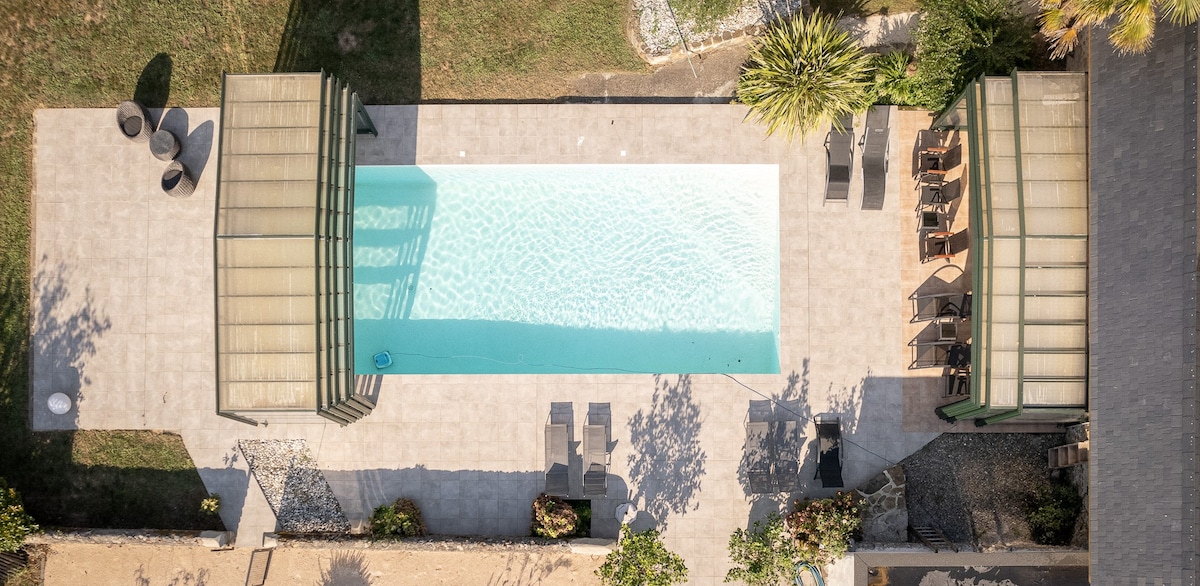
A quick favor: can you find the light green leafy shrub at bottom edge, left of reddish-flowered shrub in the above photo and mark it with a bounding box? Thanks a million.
[725,513,799,586]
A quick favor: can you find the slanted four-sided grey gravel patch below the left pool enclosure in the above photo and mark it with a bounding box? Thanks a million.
[238,440,350,533]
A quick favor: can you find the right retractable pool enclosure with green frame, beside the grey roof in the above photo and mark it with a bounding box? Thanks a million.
[932,72,1088,425]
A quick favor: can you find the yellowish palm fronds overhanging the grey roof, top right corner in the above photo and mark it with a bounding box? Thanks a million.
[1038,0,1200,59]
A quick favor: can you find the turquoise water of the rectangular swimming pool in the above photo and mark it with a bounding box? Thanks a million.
[354,165,779,373]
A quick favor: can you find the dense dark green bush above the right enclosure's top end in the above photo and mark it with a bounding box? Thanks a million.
[912,0,1037,110]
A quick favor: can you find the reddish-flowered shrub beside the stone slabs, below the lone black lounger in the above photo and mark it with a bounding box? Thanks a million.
[787,492,863,566]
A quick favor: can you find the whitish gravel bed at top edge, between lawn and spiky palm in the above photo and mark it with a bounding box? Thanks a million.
[634,0,804,55]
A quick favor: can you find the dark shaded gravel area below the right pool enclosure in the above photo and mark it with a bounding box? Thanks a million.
[901,433,1066,551]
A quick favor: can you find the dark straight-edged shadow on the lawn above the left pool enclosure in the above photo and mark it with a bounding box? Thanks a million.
[275,0,421,103]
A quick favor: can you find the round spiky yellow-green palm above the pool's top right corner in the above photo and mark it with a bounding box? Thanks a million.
[737,11,874,140]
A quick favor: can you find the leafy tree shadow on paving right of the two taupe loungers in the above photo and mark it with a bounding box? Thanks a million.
[628,375,707,530]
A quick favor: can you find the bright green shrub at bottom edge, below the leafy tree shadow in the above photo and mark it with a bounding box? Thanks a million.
[596,525,688,586]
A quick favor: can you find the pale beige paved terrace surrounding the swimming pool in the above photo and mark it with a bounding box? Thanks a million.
[31,104,993,584]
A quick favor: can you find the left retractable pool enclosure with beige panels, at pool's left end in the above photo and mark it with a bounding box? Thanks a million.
[214,73,374,425]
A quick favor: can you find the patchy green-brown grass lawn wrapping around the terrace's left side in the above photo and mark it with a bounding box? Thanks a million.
[0,0,646,528]
